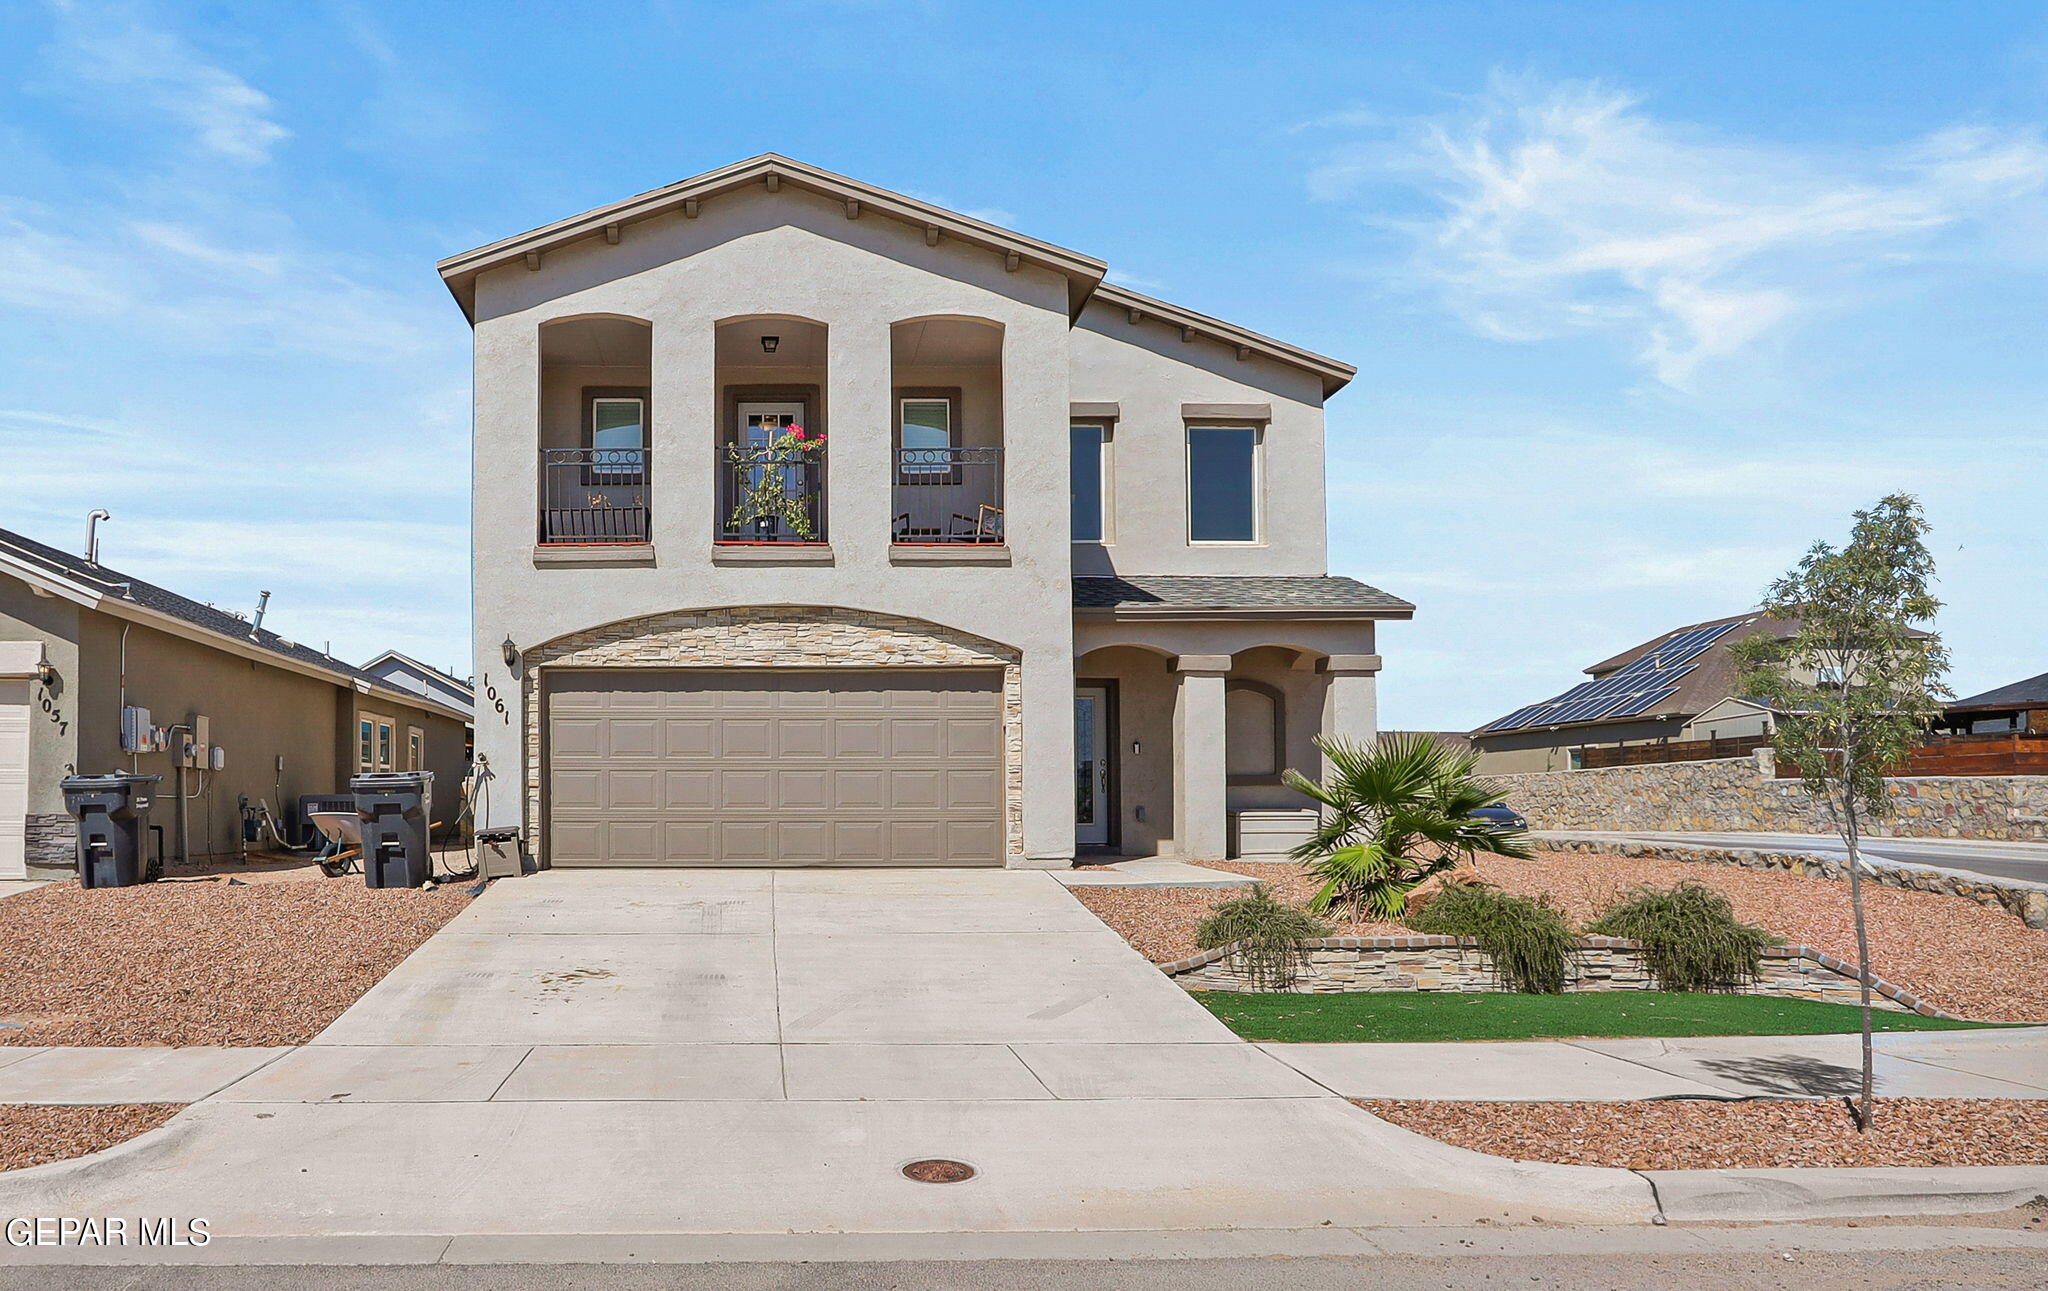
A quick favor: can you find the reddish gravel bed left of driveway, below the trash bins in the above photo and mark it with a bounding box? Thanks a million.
[0,877,469,1045]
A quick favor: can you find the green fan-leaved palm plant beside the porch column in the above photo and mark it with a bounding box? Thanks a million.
[1284,734,1530,920]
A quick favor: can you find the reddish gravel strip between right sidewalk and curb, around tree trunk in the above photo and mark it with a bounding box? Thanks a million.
[1354,1098,2048,1170]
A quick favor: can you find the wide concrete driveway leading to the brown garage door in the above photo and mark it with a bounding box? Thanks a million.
[0,871,1655,1240]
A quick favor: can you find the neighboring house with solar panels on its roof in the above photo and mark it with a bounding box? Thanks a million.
[1473,611,1790,775]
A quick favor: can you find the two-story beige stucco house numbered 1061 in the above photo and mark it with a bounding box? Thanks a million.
[440,156,1413,867]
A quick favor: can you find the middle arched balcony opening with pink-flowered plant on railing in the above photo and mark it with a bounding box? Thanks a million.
[713,316,827,545]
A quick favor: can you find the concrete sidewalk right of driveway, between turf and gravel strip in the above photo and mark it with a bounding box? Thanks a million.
[1260,1027,2048,1102]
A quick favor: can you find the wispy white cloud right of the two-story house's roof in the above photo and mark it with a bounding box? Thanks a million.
[1311,76,2048,389]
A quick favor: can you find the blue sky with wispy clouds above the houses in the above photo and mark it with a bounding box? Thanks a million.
[0,0,2048,727]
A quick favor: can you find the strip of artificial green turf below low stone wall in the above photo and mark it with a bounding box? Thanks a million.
[1194,990,1987,1043]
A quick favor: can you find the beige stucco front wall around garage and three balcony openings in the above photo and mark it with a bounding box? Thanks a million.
[475,191,1073,859]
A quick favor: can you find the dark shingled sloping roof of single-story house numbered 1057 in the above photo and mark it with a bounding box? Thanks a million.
[0,529,469,721]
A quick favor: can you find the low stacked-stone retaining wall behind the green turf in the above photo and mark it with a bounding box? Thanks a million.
[1159,936,1948,1018]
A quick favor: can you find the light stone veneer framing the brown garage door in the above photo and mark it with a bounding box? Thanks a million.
[520,605,1024,865]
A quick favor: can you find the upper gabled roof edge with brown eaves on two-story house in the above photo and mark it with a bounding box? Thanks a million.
[438,152,1358,398]
